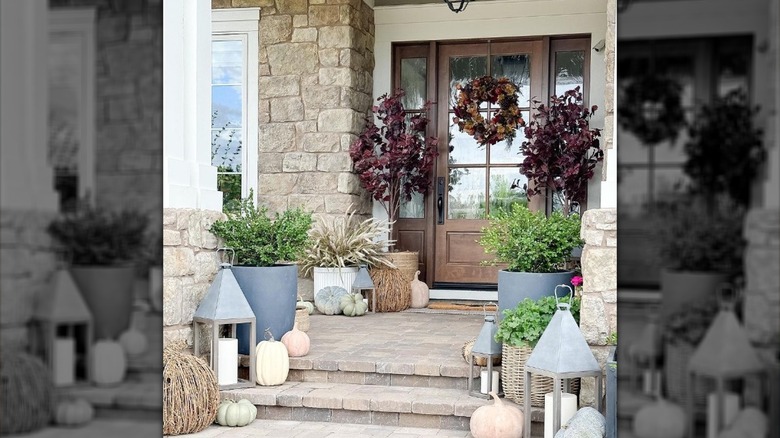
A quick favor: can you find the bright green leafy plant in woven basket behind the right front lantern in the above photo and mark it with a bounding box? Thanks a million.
[495,292,581,406]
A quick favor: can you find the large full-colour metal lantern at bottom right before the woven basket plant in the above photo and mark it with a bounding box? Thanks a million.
[523,284,603,438]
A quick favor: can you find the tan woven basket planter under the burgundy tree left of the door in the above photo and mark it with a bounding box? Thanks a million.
[370,251,418,312]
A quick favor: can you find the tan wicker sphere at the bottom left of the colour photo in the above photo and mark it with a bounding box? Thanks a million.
[163,344,220,435]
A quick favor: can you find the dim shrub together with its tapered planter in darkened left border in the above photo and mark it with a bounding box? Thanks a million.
[46,202,149,339]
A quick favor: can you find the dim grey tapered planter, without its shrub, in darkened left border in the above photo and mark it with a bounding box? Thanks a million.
[70,264,135,340]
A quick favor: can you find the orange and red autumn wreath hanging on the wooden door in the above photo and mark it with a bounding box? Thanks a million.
[452,76,525,146]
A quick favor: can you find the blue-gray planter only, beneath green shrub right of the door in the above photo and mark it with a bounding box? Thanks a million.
[498,270,574,319]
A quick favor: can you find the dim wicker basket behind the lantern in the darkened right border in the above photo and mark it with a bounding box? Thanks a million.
[664,342,715,409]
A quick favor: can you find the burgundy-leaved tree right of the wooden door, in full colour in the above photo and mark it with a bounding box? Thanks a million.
[520,87,604,215]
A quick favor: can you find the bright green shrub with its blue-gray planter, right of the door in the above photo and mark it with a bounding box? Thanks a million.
[479,203,582,311]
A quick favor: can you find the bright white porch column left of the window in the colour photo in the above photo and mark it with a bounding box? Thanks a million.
[163,0,222,211]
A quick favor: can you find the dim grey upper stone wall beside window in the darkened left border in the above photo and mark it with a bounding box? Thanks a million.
[50,0,163,228]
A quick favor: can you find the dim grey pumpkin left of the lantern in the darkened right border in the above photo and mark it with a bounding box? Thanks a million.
[634,397,687,438]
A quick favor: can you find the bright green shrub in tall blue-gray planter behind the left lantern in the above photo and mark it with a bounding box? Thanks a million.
[210,193,312,353]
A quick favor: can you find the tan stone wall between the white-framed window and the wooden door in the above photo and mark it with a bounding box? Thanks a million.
[212,0,374,219]
